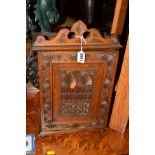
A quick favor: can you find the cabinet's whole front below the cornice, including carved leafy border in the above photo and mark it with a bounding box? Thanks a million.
[39,52,117,133]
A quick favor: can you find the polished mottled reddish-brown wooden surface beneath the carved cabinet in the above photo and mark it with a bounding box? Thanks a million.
[26,87,129,155]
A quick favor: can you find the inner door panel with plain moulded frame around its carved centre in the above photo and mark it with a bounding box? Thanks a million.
[52,64,105,122]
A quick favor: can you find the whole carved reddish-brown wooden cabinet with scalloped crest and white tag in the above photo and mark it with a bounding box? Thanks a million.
[33,21,121,135]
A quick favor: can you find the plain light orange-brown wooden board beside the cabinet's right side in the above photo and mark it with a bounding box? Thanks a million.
[109,37,129,133]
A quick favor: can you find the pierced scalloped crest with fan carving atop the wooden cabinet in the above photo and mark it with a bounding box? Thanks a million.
[34,20,119,47]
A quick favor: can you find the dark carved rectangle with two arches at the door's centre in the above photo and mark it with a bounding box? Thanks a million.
[58,67,97,117]
